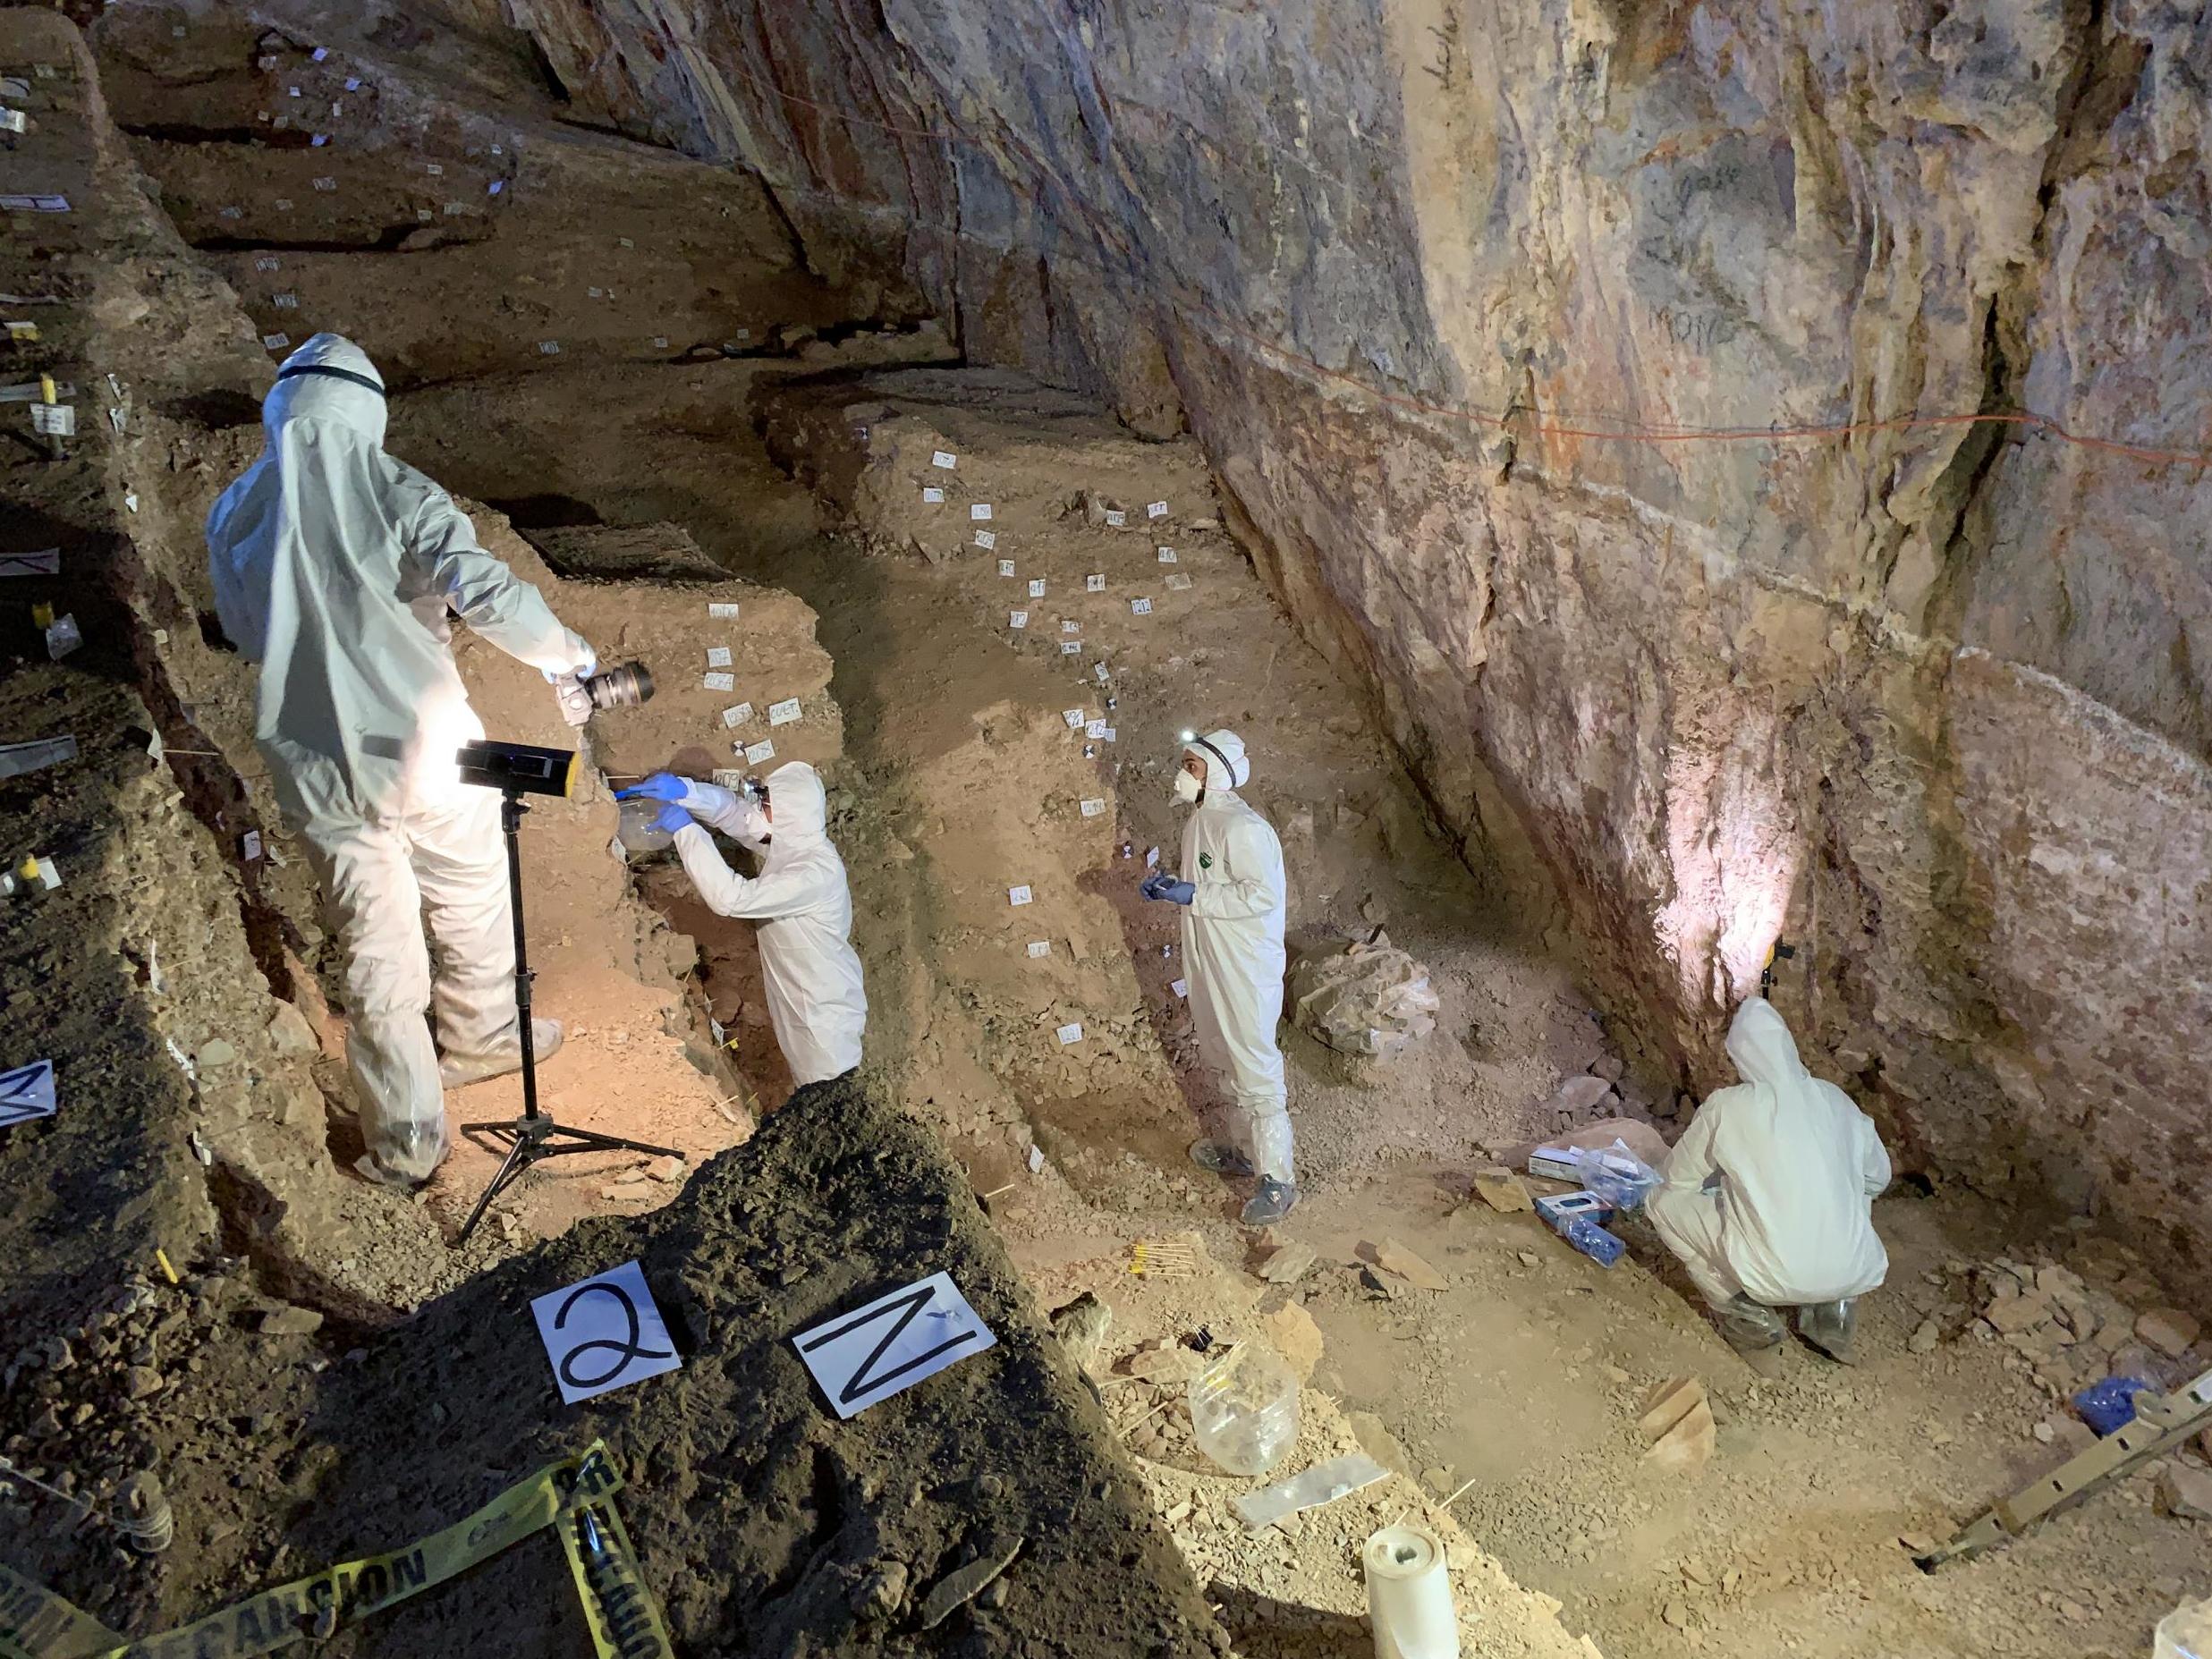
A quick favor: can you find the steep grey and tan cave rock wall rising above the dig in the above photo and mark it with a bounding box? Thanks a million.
[462,0,2212,1252]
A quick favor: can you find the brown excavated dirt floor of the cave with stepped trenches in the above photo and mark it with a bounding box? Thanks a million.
[0,4,2212,1659]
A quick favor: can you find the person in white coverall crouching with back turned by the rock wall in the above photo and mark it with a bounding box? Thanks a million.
[1646,997,1889,1371]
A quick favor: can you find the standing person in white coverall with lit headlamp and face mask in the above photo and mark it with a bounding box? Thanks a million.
[1141,732,1299,1225]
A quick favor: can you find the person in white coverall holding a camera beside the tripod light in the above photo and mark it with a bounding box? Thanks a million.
[208,334,597,1186]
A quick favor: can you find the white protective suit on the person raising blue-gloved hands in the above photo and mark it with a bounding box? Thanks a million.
[674,761,867,1084]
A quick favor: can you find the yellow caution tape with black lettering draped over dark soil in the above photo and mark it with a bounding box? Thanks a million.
[0,1440,670,1659]
